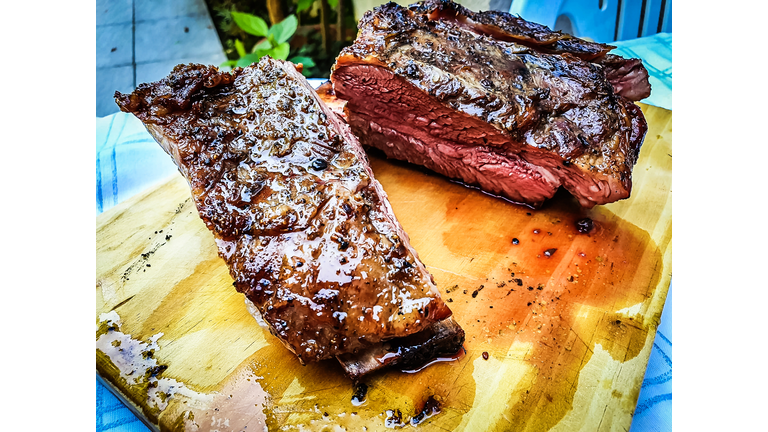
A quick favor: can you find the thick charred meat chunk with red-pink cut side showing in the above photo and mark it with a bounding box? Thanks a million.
[331,0,650,207]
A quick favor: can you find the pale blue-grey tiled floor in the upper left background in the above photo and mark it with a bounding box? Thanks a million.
[96,0,226,117]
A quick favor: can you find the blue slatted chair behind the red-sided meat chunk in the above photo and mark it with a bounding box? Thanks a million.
[509,0,672,43]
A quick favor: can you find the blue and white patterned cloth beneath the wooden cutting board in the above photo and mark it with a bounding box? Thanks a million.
[96,33,672,432]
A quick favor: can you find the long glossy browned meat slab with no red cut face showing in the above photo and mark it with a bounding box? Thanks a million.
[115,57,464,369]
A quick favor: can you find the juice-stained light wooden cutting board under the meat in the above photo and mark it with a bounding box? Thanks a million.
[96,105,672,431]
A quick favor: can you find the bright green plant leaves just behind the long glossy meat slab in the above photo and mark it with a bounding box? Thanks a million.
[222,11,315,75]
